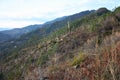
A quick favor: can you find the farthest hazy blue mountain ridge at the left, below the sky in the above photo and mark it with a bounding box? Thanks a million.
[0,25,41,43]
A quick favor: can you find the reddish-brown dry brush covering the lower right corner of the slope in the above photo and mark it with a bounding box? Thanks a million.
[49,33,120,80]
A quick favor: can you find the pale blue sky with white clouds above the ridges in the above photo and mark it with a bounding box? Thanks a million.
[0,0,120,28]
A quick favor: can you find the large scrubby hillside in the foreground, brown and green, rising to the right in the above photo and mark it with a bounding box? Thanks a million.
[0,7,120,80]
